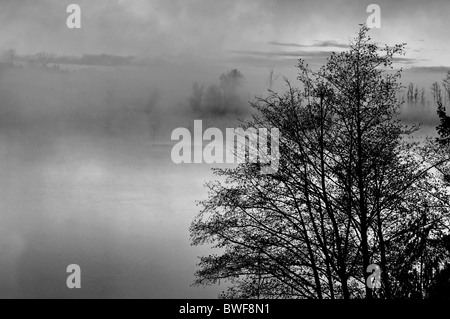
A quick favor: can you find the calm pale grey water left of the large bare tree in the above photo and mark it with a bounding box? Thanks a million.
[0,132,223,298]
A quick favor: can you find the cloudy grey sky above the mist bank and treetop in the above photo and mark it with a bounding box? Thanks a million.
[0,0,450,67]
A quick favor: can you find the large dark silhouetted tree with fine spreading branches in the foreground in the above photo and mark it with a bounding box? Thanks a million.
[190,26,450,299]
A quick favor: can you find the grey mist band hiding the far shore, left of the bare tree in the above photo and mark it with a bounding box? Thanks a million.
[0,64,252,143]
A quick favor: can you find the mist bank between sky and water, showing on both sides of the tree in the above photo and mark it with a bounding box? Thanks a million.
[0,59,445,154]
